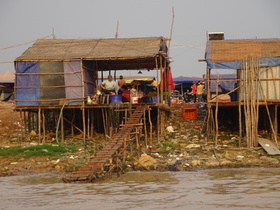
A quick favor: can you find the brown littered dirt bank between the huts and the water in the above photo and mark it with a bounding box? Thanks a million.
[0,103,280,176]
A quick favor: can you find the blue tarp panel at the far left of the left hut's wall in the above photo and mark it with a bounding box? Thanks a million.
[15,61,40,106]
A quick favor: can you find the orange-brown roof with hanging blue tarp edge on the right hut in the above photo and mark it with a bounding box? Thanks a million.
[205,39,280,69]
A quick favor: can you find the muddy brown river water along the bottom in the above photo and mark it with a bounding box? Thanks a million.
[0,169,280,210]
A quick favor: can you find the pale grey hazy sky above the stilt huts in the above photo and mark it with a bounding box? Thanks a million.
[0,0,280,77]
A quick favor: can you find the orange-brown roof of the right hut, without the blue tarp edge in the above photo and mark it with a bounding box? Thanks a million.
[206,39,280,63]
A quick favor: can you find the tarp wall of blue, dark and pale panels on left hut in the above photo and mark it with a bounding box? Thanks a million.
[15,61,93,106]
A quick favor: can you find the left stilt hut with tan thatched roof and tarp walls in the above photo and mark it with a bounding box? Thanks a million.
[14,37,174,148]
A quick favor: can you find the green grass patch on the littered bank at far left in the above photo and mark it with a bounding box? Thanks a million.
[0,145,74,157]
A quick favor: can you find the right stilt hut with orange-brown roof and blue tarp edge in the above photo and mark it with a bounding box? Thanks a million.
[204,34,280,147]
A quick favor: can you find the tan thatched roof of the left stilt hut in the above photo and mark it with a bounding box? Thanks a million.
[16,37,166,61]
